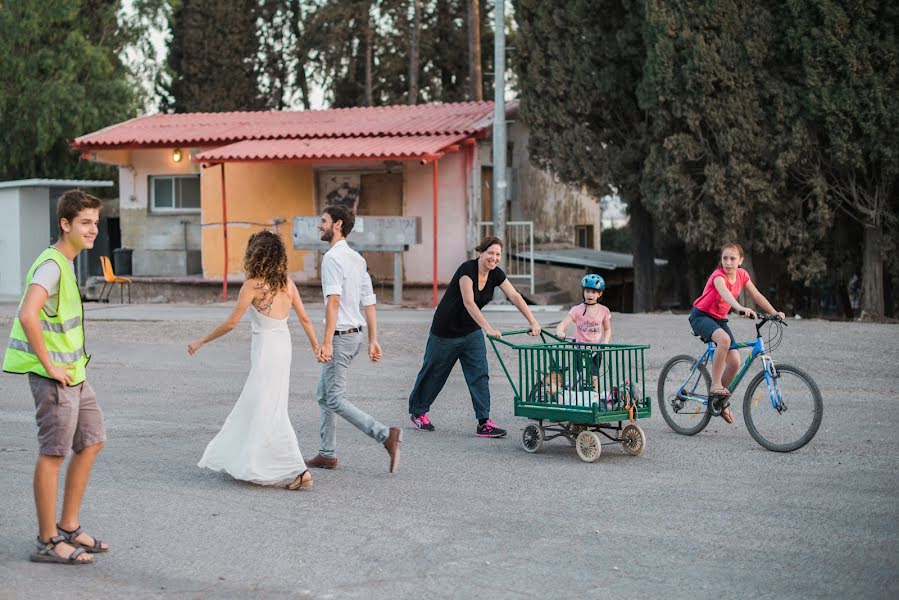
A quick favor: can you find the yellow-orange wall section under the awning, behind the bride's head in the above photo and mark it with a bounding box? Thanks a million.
[201,162,316,278]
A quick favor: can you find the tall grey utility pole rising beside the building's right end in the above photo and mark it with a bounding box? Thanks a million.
[491,0,507,267]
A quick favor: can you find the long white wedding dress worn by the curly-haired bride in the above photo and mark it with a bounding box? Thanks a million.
[198,305,306,485]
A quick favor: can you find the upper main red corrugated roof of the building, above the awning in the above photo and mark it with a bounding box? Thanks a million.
[72,102,506,150]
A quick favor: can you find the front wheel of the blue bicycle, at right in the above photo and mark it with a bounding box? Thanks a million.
[743,365,824,452]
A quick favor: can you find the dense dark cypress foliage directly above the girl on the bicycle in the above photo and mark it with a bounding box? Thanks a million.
[641,0,832,280]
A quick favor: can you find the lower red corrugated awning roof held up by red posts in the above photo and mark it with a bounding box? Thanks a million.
[196,134,468,162]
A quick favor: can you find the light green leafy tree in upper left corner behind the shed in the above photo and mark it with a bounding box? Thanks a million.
[0,0,138,179]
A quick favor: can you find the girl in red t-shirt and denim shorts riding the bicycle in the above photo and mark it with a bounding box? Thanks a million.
[690,242,785,423]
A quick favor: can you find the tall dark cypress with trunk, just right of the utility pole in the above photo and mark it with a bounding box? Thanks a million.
[512,0,655,312]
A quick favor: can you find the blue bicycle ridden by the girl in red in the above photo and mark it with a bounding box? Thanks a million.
[658,315,824,452]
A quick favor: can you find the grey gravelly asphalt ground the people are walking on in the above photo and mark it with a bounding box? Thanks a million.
[0,305,899,598]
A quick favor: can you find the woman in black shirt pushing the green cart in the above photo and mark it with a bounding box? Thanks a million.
[409,236,540,437]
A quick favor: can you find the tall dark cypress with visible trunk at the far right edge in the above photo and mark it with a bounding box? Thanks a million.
[786,0,899,318]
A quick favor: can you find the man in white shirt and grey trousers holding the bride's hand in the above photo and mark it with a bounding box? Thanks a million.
[306,206,402,473]
